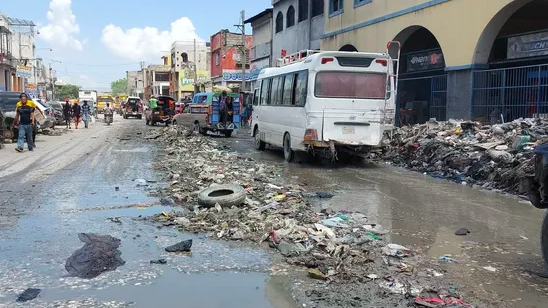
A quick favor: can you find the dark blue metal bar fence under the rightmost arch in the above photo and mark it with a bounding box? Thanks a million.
[472,65,548,124]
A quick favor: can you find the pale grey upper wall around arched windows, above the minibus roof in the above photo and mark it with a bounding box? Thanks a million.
[272,0,328,60]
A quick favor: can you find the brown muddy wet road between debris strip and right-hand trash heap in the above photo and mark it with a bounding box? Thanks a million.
[225,134,548,308]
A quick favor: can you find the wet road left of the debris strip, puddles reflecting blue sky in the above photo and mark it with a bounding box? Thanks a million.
[0,117,293,308]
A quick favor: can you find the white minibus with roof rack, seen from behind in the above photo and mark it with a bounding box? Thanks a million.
[251,42,399,161]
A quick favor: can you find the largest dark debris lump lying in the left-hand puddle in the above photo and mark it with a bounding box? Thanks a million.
[65,233,126,279]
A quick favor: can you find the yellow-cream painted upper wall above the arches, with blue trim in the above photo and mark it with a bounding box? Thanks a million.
[321,0,532,68]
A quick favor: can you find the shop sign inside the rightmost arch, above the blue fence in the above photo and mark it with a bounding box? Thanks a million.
[507,32,548,59]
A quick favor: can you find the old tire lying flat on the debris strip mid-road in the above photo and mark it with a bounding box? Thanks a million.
[198,184,245,207]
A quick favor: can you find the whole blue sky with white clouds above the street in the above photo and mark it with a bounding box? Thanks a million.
[0,0,272,90]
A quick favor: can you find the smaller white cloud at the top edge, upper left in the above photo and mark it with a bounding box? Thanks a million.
[39,0,84,51]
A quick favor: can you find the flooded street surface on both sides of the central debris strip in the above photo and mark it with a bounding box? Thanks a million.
[0,118,548,308]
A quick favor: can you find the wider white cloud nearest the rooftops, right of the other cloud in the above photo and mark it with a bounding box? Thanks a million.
[101,17,203,61]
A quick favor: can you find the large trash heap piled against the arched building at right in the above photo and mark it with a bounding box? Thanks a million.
[383,119,548,194]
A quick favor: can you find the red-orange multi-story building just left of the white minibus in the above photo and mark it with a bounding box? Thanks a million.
[211,30,253,92]
